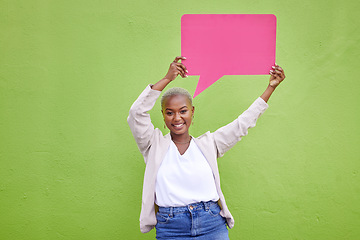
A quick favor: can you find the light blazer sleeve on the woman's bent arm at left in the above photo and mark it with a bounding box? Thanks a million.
[127,85,161,155]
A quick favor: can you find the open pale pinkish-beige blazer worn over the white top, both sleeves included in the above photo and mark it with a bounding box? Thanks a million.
[127,85,268,233]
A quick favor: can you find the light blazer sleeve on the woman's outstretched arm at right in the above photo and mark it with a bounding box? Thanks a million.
[213,97,269,157]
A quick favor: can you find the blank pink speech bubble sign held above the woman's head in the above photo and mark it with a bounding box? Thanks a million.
[181,14,276,97]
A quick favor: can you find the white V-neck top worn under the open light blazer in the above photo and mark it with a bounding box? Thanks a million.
[155,140,219,207]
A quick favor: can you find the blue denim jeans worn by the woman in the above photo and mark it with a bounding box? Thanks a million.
[155,201,229,240]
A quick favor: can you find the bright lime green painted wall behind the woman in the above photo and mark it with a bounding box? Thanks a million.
[0,0,360,240]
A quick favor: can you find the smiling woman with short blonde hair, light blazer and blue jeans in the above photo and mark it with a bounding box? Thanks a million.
[128,57,285,240]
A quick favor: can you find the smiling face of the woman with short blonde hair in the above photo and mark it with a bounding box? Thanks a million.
[162,95,194,135]
